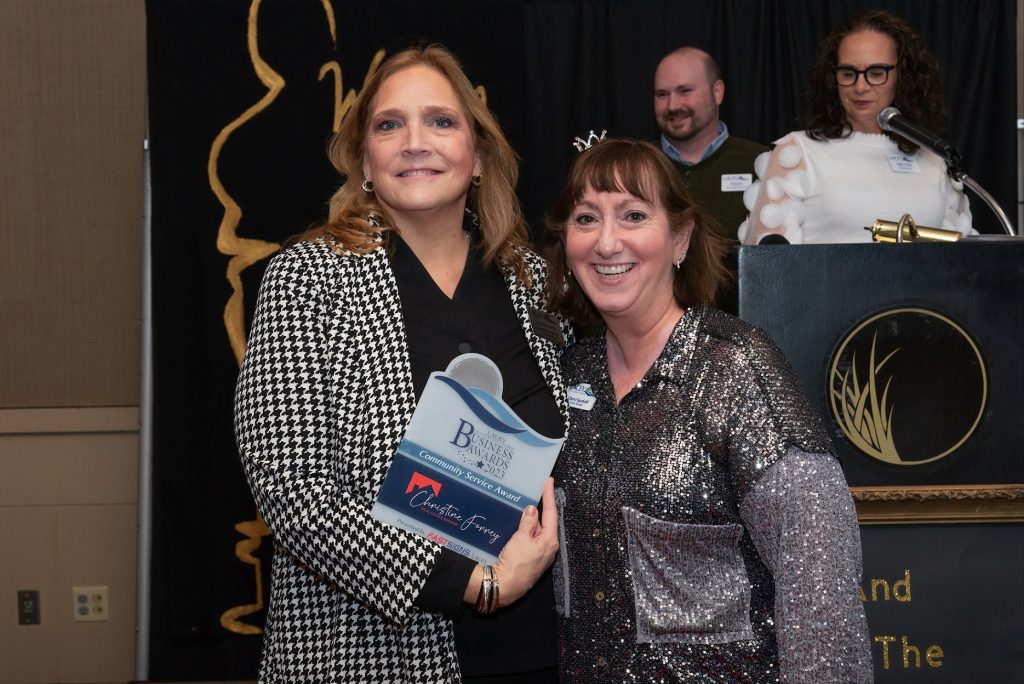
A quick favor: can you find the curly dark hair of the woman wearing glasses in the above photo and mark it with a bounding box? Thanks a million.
[804,9,946,153]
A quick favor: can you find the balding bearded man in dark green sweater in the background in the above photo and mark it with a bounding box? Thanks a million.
[654,47,768,244]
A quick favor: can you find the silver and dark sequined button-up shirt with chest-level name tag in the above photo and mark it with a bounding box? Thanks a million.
[555,307,871,684]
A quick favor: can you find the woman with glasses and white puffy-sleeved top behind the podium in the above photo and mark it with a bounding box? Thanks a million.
[739,9,976,245]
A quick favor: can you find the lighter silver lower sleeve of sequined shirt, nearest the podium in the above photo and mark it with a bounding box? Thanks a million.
[739,448,873,682]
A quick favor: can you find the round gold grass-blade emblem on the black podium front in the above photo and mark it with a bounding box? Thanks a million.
[828,307,988,466]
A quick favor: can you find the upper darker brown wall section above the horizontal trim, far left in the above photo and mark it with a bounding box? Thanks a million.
[0,0,145,409]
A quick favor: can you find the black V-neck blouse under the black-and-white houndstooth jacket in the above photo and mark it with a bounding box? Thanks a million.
[389,233,564,676]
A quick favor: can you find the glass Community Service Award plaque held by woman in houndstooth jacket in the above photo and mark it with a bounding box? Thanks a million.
[373,353,563,564]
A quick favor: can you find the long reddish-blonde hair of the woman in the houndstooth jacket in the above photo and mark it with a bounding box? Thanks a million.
[300,44,529,281]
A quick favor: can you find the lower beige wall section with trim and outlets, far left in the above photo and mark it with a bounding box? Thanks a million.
[0,409,138,684]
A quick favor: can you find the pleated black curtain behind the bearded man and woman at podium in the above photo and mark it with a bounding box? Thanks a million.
[516,0,1017,232]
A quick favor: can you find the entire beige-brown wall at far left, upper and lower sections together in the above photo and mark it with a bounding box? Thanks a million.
[0,0,145,684]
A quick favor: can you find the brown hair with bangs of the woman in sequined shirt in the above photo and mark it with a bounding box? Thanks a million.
[543,139,729,328]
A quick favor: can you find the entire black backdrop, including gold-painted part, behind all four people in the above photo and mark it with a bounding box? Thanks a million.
[146,0,1017,681]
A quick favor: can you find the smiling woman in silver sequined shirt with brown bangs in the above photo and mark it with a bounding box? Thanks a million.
[545,140,871,684]
